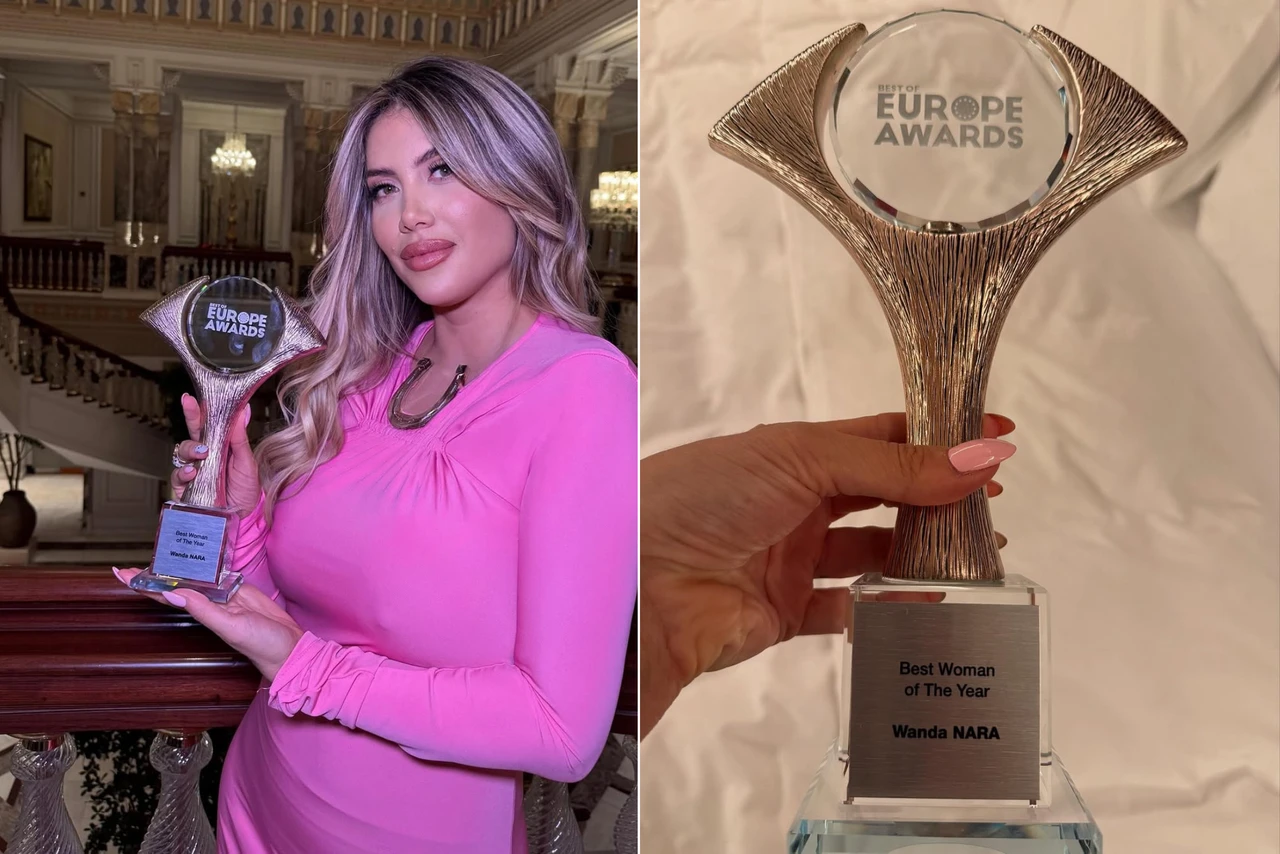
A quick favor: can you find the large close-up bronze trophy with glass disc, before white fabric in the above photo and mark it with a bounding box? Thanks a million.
[710,12,1187,854]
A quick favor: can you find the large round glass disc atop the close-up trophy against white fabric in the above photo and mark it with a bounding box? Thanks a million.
[815,12,1076,233]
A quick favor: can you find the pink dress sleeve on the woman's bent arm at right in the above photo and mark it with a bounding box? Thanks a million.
[269,353,639,781]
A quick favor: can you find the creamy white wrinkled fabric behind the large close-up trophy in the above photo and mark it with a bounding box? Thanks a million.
[640,0,1280,854]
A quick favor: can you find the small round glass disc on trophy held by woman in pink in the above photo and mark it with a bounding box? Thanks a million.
[183,275,284,374]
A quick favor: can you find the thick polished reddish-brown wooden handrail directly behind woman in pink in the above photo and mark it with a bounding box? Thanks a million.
[0,566,637,735]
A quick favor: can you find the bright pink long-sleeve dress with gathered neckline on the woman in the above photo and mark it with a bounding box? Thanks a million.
[218,315,637,854]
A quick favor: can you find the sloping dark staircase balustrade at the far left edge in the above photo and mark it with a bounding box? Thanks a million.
[0,273,172,479]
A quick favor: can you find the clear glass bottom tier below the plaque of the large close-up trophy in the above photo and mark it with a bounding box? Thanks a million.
[787,745,1102,854]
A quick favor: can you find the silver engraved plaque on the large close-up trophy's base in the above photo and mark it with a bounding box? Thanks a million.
[849,602,1041,800]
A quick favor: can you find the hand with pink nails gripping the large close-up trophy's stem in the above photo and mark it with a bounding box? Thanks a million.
[640,412,1014,735]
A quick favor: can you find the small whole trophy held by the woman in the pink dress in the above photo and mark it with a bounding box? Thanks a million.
[129,275,324,602]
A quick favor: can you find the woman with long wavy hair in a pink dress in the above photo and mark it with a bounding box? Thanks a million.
[119,58,637,854]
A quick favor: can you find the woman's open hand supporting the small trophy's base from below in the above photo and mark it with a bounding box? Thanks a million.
[111,567,302,681]
